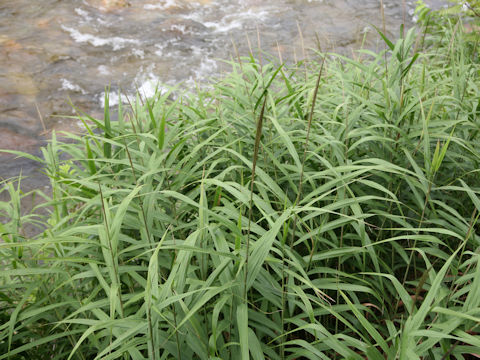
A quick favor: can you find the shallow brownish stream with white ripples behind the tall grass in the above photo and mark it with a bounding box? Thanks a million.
[0,0,444,197]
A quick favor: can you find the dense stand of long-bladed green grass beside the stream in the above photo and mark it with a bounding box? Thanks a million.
[0,3,480,360]
